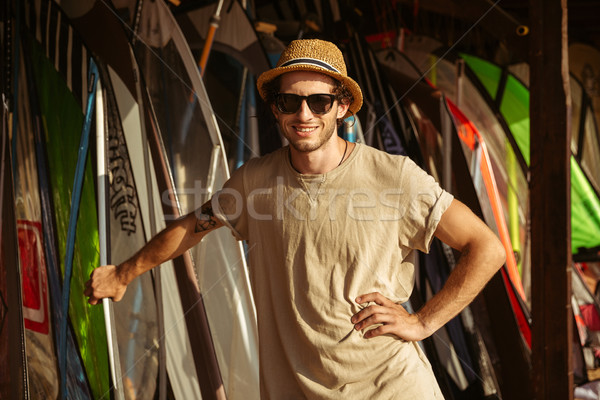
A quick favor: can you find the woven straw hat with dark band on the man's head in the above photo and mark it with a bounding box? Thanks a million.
[256,39,362,117]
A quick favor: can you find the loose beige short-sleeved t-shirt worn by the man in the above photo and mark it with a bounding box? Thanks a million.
[213,144,452,400]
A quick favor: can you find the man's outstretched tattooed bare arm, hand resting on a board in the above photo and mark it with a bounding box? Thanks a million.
[84,200,223,304]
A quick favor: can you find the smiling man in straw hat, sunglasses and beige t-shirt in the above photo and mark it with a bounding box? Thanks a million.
[85,40,504,400]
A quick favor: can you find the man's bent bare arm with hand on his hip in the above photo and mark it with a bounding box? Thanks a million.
[351,200,506,341]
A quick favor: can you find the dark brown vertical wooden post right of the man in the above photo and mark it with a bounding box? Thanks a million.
[529,0,573,400]
